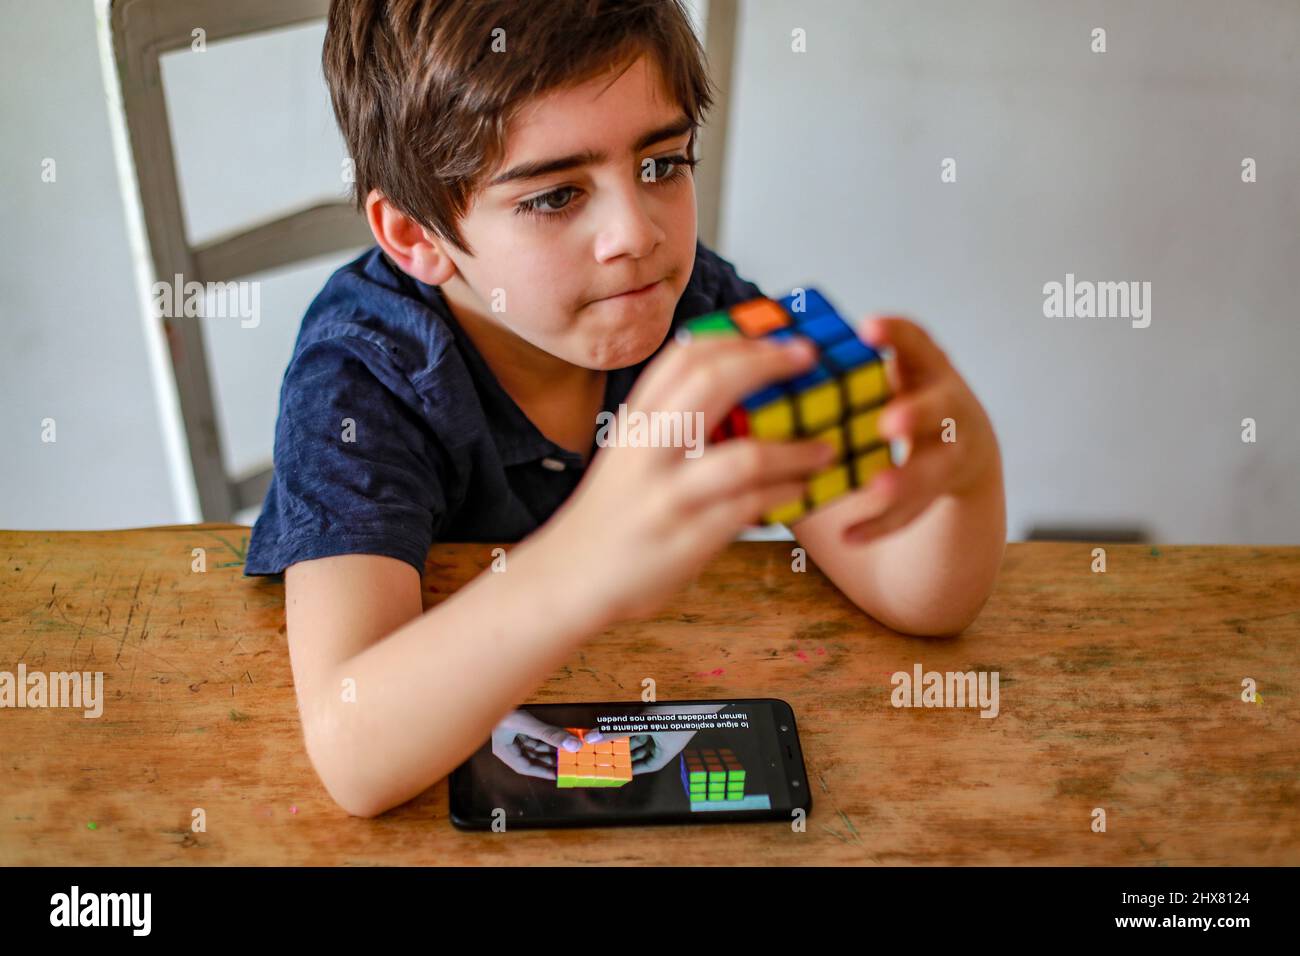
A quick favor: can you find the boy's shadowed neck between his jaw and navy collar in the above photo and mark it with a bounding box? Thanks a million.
[441,280,606,459]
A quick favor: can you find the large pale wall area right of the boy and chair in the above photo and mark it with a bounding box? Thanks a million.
[723,0,1300,544]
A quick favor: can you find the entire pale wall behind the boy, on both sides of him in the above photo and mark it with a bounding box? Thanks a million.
[0,0,1300,544]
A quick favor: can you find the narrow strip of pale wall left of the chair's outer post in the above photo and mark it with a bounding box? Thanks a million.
[0,0,174,529]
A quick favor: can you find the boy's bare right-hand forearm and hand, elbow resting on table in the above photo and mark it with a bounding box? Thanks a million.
[792,317,1006,635]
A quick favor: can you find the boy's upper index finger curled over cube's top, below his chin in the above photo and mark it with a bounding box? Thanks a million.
[628,336,816,433]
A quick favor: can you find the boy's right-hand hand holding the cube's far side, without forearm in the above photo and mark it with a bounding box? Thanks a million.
[844,316,998,544]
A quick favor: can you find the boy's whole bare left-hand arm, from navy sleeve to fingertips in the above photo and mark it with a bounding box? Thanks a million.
[285,338,828,816]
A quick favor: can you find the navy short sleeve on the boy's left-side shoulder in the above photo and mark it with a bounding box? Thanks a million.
[244,336,446,575]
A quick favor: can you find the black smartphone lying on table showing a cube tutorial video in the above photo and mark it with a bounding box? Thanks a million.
[450,697,813,830]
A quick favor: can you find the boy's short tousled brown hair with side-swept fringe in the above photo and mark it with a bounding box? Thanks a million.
[321,0,712,255]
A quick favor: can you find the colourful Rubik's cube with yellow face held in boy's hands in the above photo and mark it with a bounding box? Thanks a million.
[683,289,894,524]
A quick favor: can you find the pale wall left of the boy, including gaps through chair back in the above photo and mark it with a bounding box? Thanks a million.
[0,0,366,529]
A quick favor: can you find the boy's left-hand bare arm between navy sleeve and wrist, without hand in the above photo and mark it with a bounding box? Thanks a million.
[285,537,605,817]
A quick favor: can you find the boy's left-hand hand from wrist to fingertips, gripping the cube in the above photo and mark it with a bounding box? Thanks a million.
[538,337,835,623]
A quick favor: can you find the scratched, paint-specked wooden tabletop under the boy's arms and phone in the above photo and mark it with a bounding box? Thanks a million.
[0,525,1300,865]
